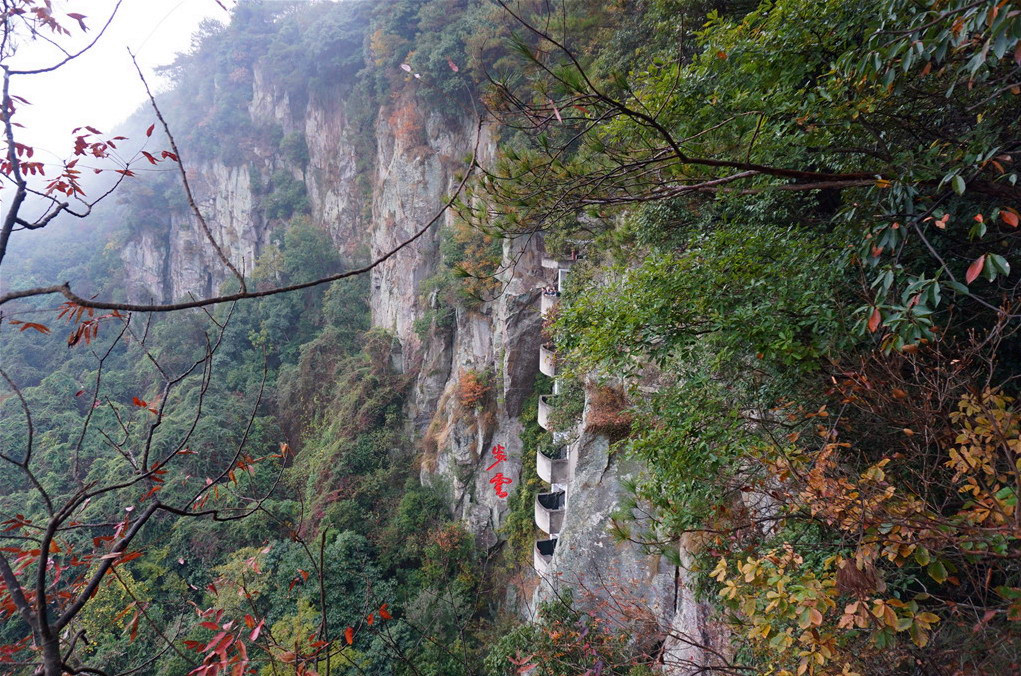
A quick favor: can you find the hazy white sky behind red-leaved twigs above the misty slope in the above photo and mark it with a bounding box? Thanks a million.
[11,0,235,162]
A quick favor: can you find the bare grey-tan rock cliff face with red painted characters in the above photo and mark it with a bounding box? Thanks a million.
[121,64,702,673]
